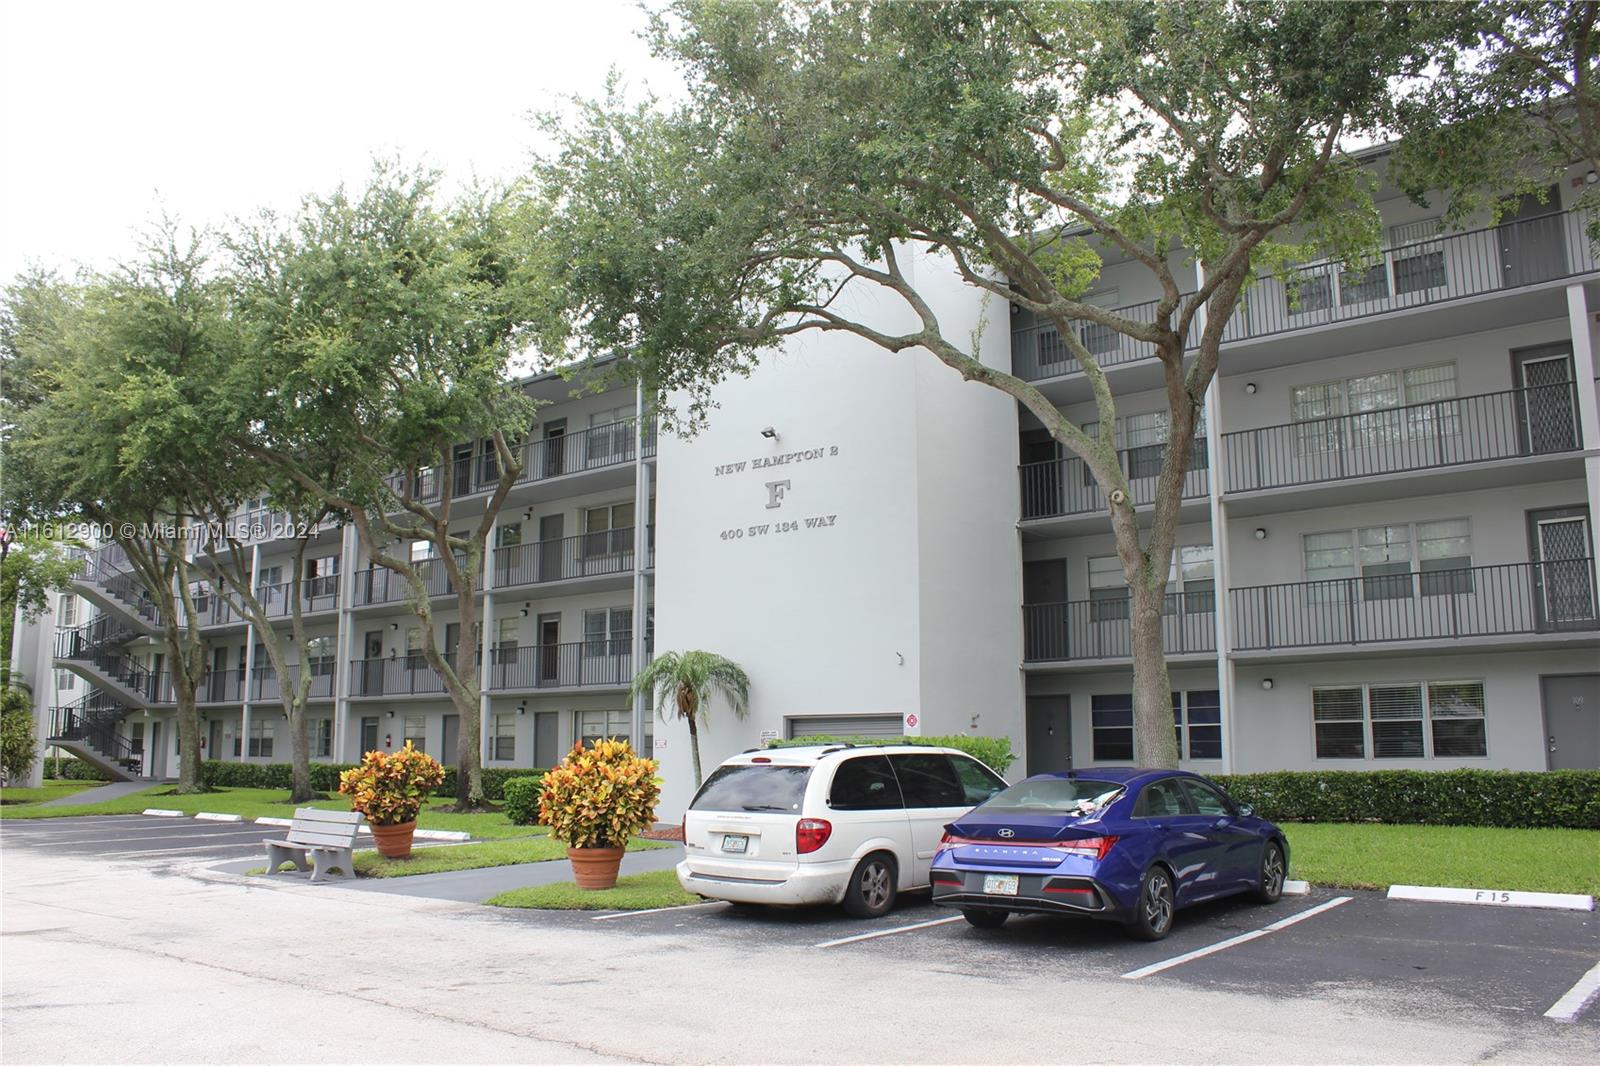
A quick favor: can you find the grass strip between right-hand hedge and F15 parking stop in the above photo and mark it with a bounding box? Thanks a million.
[1283,823,1600,896]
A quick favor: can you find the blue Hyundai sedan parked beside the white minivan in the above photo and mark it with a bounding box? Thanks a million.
[931,770,1290,940]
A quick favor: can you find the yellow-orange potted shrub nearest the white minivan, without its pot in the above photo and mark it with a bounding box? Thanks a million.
[539,739,661,848]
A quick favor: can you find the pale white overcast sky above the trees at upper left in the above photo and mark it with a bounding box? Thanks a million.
[0,0,675,283]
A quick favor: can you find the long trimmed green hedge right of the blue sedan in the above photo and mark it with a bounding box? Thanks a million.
[1214,770,1600,829]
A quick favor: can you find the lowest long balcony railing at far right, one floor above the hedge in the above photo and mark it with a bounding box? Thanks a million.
[1229,559,1600,651]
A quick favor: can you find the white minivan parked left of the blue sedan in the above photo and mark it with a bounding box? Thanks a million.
[678,744,1005,917]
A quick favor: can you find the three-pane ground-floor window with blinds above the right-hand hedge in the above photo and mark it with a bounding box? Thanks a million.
[1312,680,1488,759]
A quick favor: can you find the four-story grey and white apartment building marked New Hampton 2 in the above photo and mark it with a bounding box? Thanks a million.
[15,153,1600,813]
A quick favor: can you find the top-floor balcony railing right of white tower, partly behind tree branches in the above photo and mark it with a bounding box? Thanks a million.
[1011,211,1600,381]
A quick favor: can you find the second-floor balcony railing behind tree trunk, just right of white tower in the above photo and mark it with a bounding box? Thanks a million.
[1022,591,1216,663]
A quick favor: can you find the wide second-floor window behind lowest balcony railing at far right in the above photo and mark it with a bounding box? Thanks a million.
[1301,519,1474,603]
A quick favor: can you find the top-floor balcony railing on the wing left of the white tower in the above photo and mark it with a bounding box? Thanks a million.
[380,421,656,503]
